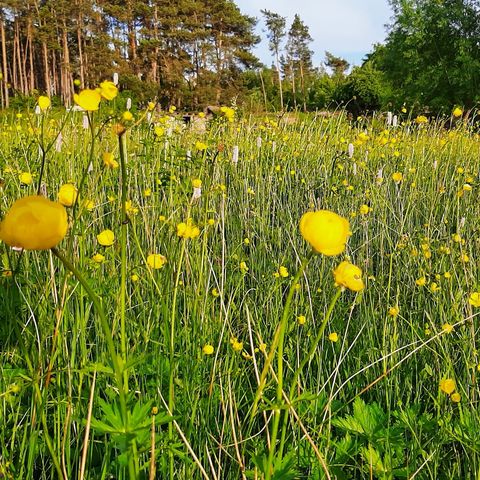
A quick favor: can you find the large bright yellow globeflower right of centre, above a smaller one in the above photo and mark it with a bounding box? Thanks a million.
[300,210,351,255]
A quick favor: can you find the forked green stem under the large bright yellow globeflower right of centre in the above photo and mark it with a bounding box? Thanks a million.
[262,252,313,480]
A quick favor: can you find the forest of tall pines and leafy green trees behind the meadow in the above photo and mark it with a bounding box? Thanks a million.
[0,0,480,113]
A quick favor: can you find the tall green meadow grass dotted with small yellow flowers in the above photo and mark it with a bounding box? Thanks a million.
[0,106,480,479]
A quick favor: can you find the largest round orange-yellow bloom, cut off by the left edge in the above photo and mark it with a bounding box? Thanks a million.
[0,195,68,250]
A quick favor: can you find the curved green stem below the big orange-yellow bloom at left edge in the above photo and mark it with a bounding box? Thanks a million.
[52,248,137,479]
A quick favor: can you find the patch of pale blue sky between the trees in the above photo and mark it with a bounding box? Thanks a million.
[235,0,392,66]
